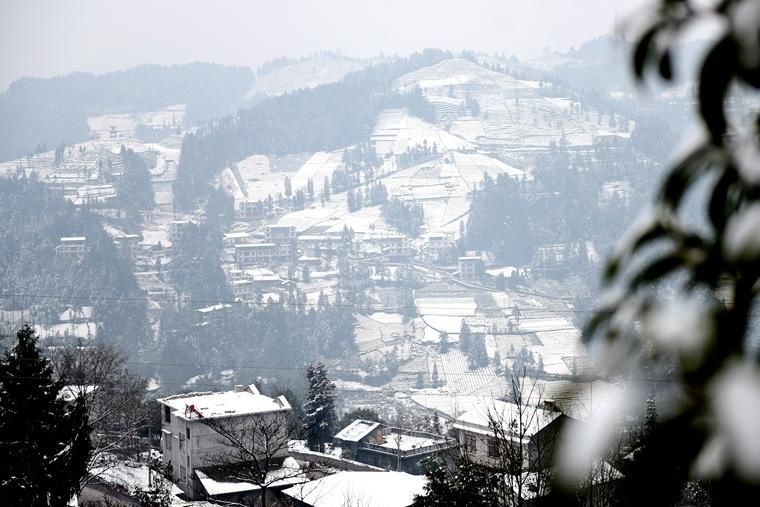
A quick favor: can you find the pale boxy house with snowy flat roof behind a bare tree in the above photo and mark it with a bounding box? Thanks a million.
[158,385,291,495]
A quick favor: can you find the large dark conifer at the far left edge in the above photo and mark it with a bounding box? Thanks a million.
[0,325,91,506]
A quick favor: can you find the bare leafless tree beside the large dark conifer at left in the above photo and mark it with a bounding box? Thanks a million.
[53,342,148,488]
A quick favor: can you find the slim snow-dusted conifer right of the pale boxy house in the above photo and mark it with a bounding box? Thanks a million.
[304,363,336,452]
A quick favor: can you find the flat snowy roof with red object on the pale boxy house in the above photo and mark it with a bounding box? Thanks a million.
[158,385,291,420]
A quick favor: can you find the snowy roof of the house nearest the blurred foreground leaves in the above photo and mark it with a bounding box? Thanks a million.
[454,400,562,437]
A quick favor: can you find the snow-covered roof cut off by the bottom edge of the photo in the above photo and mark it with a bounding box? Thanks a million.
[283,472,427,507]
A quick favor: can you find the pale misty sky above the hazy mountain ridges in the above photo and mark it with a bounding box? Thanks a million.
[0,0,644,90]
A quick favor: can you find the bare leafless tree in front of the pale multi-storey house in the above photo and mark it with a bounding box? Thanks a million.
[200,412,303,507]
